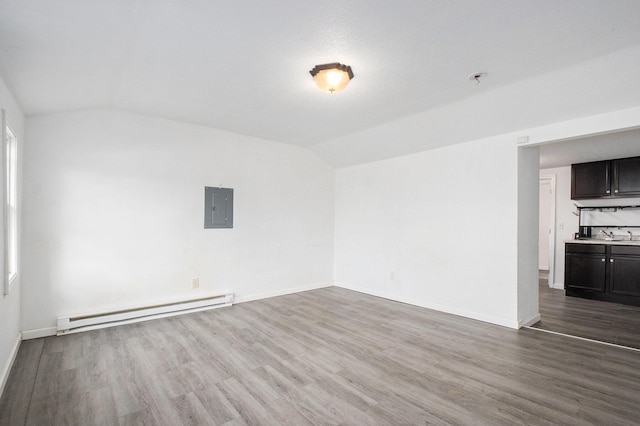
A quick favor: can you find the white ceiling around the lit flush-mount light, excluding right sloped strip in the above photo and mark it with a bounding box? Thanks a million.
[0,0,640,153]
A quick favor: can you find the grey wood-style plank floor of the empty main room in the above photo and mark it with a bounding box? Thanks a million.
[0,288,640,425]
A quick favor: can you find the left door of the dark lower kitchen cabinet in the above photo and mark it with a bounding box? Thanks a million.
[564,253,606,293]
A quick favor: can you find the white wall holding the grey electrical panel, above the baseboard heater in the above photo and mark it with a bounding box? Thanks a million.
[22,110,334,337]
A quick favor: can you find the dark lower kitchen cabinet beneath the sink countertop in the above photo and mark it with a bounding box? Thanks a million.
[564,243,640,306]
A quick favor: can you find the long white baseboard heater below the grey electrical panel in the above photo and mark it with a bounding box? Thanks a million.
[57,293,233,336]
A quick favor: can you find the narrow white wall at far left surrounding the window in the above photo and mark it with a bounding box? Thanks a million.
[0,75,25,394]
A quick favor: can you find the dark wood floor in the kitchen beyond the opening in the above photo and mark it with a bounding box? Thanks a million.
[533,274,640,350]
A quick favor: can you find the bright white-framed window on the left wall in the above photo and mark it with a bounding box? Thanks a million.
[4,124,18,294]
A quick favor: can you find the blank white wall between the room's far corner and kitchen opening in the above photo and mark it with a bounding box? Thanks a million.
[336,137,524,327]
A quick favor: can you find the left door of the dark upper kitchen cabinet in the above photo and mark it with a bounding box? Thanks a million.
[571,161,611,199]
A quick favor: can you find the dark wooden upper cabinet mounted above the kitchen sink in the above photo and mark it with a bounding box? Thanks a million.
[571,157,640,200]
